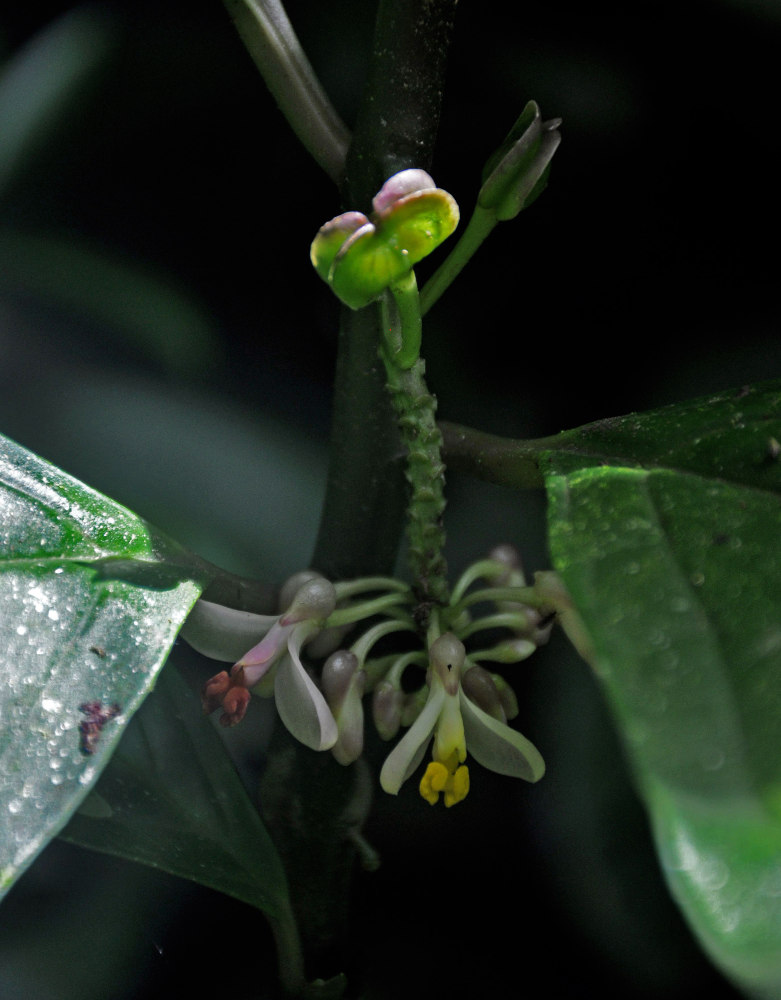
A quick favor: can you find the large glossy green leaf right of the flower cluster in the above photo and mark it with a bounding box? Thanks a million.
[545,383,781,997]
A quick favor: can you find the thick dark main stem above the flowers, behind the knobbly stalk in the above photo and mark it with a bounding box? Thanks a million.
[313,0,457,579]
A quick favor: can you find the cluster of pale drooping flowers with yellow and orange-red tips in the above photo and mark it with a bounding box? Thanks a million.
[182,546,552,806]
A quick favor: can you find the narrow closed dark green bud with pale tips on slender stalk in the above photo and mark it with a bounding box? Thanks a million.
[477,101,561,221]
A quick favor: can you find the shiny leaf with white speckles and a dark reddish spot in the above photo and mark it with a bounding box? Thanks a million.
[0,438,202,896]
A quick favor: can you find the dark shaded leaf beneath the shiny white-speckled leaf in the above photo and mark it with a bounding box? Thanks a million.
[63,665,287,916]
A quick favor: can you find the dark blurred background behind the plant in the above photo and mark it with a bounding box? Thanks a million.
[0,0,781,1000]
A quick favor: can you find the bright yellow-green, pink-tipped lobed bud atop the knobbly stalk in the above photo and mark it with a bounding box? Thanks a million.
[310,168,459,309]
